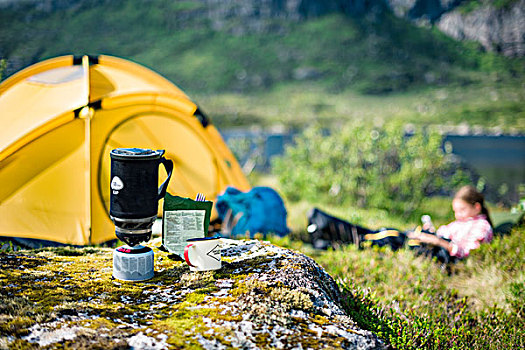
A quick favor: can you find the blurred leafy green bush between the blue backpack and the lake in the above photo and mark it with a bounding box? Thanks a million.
[274,122,468,216]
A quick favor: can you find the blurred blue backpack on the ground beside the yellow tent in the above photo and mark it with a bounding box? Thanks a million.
[216,186,290,238]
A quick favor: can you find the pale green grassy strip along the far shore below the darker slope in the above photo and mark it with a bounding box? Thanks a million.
[194,83,525,131]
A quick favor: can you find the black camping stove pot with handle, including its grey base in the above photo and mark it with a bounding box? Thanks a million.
[109,148,173,281]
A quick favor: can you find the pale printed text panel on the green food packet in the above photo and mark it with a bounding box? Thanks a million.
[162,210,206,256]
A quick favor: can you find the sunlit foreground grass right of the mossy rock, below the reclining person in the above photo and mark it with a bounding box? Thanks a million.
[332,227,525,349]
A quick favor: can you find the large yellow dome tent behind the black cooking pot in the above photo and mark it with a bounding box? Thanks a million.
[0,56,249,245]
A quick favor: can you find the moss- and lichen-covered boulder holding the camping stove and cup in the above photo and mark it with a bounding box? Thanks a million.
[0,240,384,349]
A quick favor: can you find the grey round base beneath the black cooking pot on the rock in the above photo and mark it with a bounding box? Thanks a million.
[113,245,155,281]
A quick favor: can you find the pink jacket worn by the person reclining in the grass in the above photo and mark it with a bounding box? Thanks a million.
[436,214,493,258]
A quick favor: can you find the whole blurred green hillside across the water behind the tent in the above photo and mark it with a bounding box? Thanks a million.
[0,0,525,130]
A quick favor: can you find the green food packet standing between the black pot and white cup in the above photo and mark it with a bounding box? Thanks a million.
[162,193,213,257]
